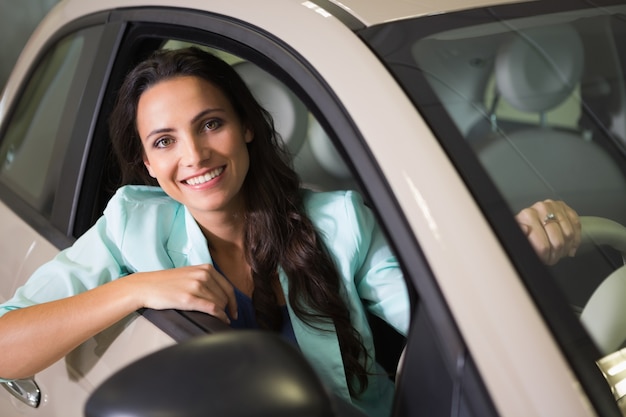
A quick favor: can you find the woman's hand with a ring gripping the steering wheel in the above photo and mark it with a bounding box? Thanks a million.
[515,200,581,265]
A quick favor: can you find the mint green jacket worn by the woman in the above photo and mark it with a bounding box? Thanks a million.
[0,186,409,416]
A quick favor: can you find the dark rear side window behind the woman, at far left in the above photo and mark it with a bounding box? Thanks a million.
[0,28,97,217]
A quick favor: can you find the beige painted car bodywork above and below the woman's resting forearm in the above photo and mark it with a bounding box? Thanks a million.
[0,203,174,417]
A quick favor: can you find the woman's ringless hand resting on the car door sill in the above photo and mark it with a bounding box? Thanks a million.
[124,264,237,323]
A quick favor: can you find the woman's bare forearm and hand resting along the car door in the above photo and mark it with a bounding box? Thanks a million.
[0,264,237,379]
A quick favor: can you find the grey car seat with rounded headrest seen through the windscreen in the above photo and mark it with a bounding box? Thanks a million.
[477,24,626,308]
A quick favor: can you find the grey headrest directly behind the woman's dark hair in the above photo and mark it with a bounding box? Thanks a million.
[233,62,308,155]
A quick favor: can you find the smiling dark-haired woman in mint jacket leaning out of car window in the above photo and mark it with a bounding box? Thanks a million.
[0,48,409,415]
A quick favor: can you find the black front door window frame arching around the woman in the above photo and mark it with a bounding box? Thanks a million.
[70,8,495,416]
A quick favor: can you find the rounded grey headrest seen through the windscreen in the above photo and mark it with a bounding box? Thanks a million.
[495,25,584,113]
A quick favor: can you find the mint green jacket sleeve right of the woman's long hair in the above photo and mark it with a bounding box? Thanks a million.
[305,191,410,335]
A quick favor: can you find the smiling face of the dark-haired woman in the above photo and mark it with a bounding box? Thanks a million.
[137,76,253,219]
